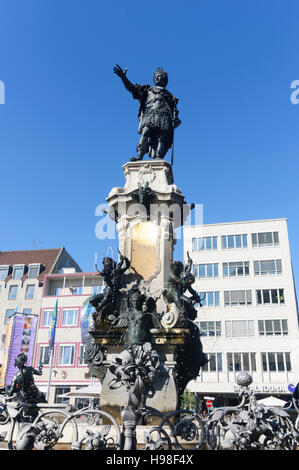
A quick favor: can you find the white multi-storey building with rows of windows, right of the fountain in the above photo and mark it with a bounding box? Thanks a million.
[184,218,299,399]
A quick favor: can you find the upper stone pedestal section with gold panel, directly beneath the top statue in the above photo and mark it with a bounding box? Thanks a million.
[107,160,191,295]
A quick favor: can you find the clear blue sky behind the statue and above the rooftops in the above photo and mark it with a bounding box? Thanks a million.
[0,0,299,283]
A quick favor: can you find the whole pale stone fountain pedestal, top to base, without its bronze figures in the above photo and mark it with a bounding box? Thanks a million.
[90,160,197,420]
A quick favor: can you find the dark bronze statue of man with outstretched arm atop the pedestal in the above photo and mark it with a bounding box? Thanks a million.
[113,65,181,161]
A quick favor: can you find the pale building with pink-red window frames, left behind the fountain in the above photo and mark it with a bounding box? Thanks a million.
[34,270,102,403]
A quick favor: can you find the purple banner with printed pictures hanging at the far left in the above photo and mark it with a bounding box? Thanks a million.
[5,313,37,385]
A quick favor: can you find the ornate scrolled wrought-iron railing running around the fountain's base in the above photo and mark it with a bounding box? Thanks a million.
[0,374,299,451]
